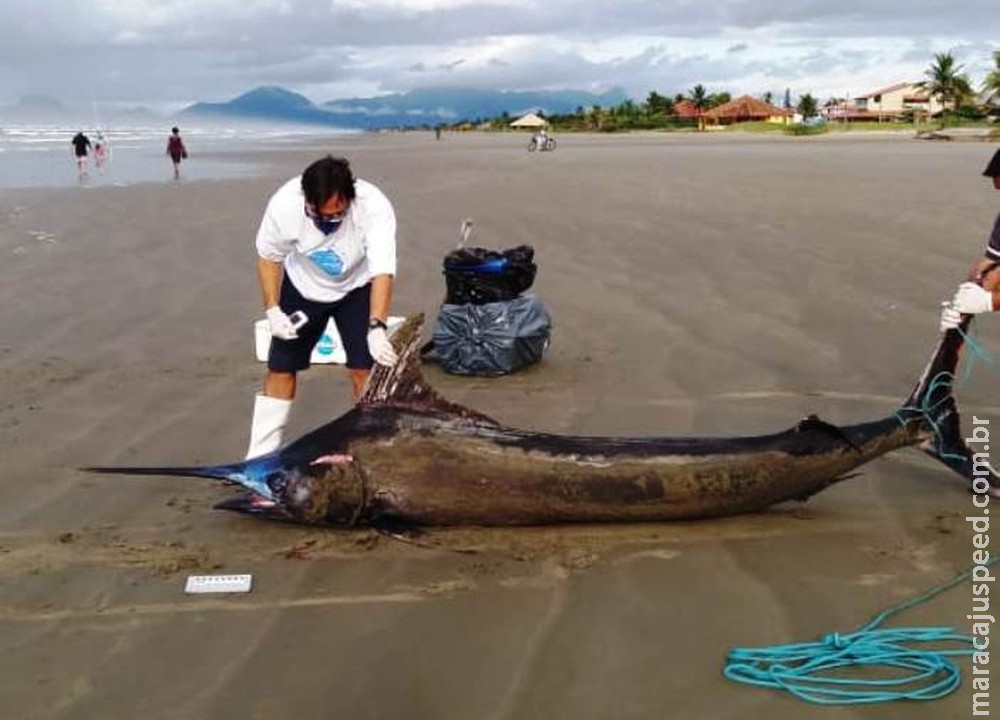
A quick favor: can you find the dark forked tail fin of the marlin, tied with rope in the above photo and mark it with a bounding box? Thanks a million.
[897,322,1000,496]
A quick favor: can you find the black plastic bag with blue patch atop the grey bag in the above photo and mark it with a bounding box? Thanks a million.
[443,245,538,305]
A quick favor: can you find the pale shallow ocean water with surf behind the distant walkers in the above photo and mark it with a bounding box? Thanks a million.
[0,124,351,188]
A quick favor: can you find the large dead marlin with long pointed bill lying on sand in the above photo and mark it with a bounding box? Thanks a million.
[90,316,1000,526]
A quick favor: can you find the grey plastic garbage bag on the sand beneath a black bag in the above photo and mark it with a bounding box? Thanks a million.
[426,294,552,376]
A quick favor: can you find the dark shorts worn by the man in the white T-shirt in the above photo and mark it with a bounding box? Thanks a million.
[267,275,375,373]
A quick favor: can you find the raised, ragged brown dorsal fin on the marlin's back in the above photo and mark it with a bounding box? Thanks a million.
[358,313,500,425]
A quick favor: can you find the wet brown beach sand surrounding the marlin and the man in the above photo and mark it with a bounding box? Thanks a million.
[0,133,1000,720]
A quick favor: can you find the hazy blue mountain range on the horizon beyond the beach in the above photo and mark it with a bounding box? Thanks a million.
[180,87,627,130]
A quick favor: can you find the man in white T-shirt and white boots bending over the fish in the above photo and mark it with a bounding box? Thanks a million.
[247,155,397,458]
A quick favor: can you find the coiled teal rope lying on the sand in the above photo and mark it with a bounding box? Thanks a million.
[722,557,1000,705]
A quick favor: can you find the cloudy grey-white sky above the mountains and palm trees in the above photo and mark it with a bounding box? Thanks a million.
[0,0,1000,111]
